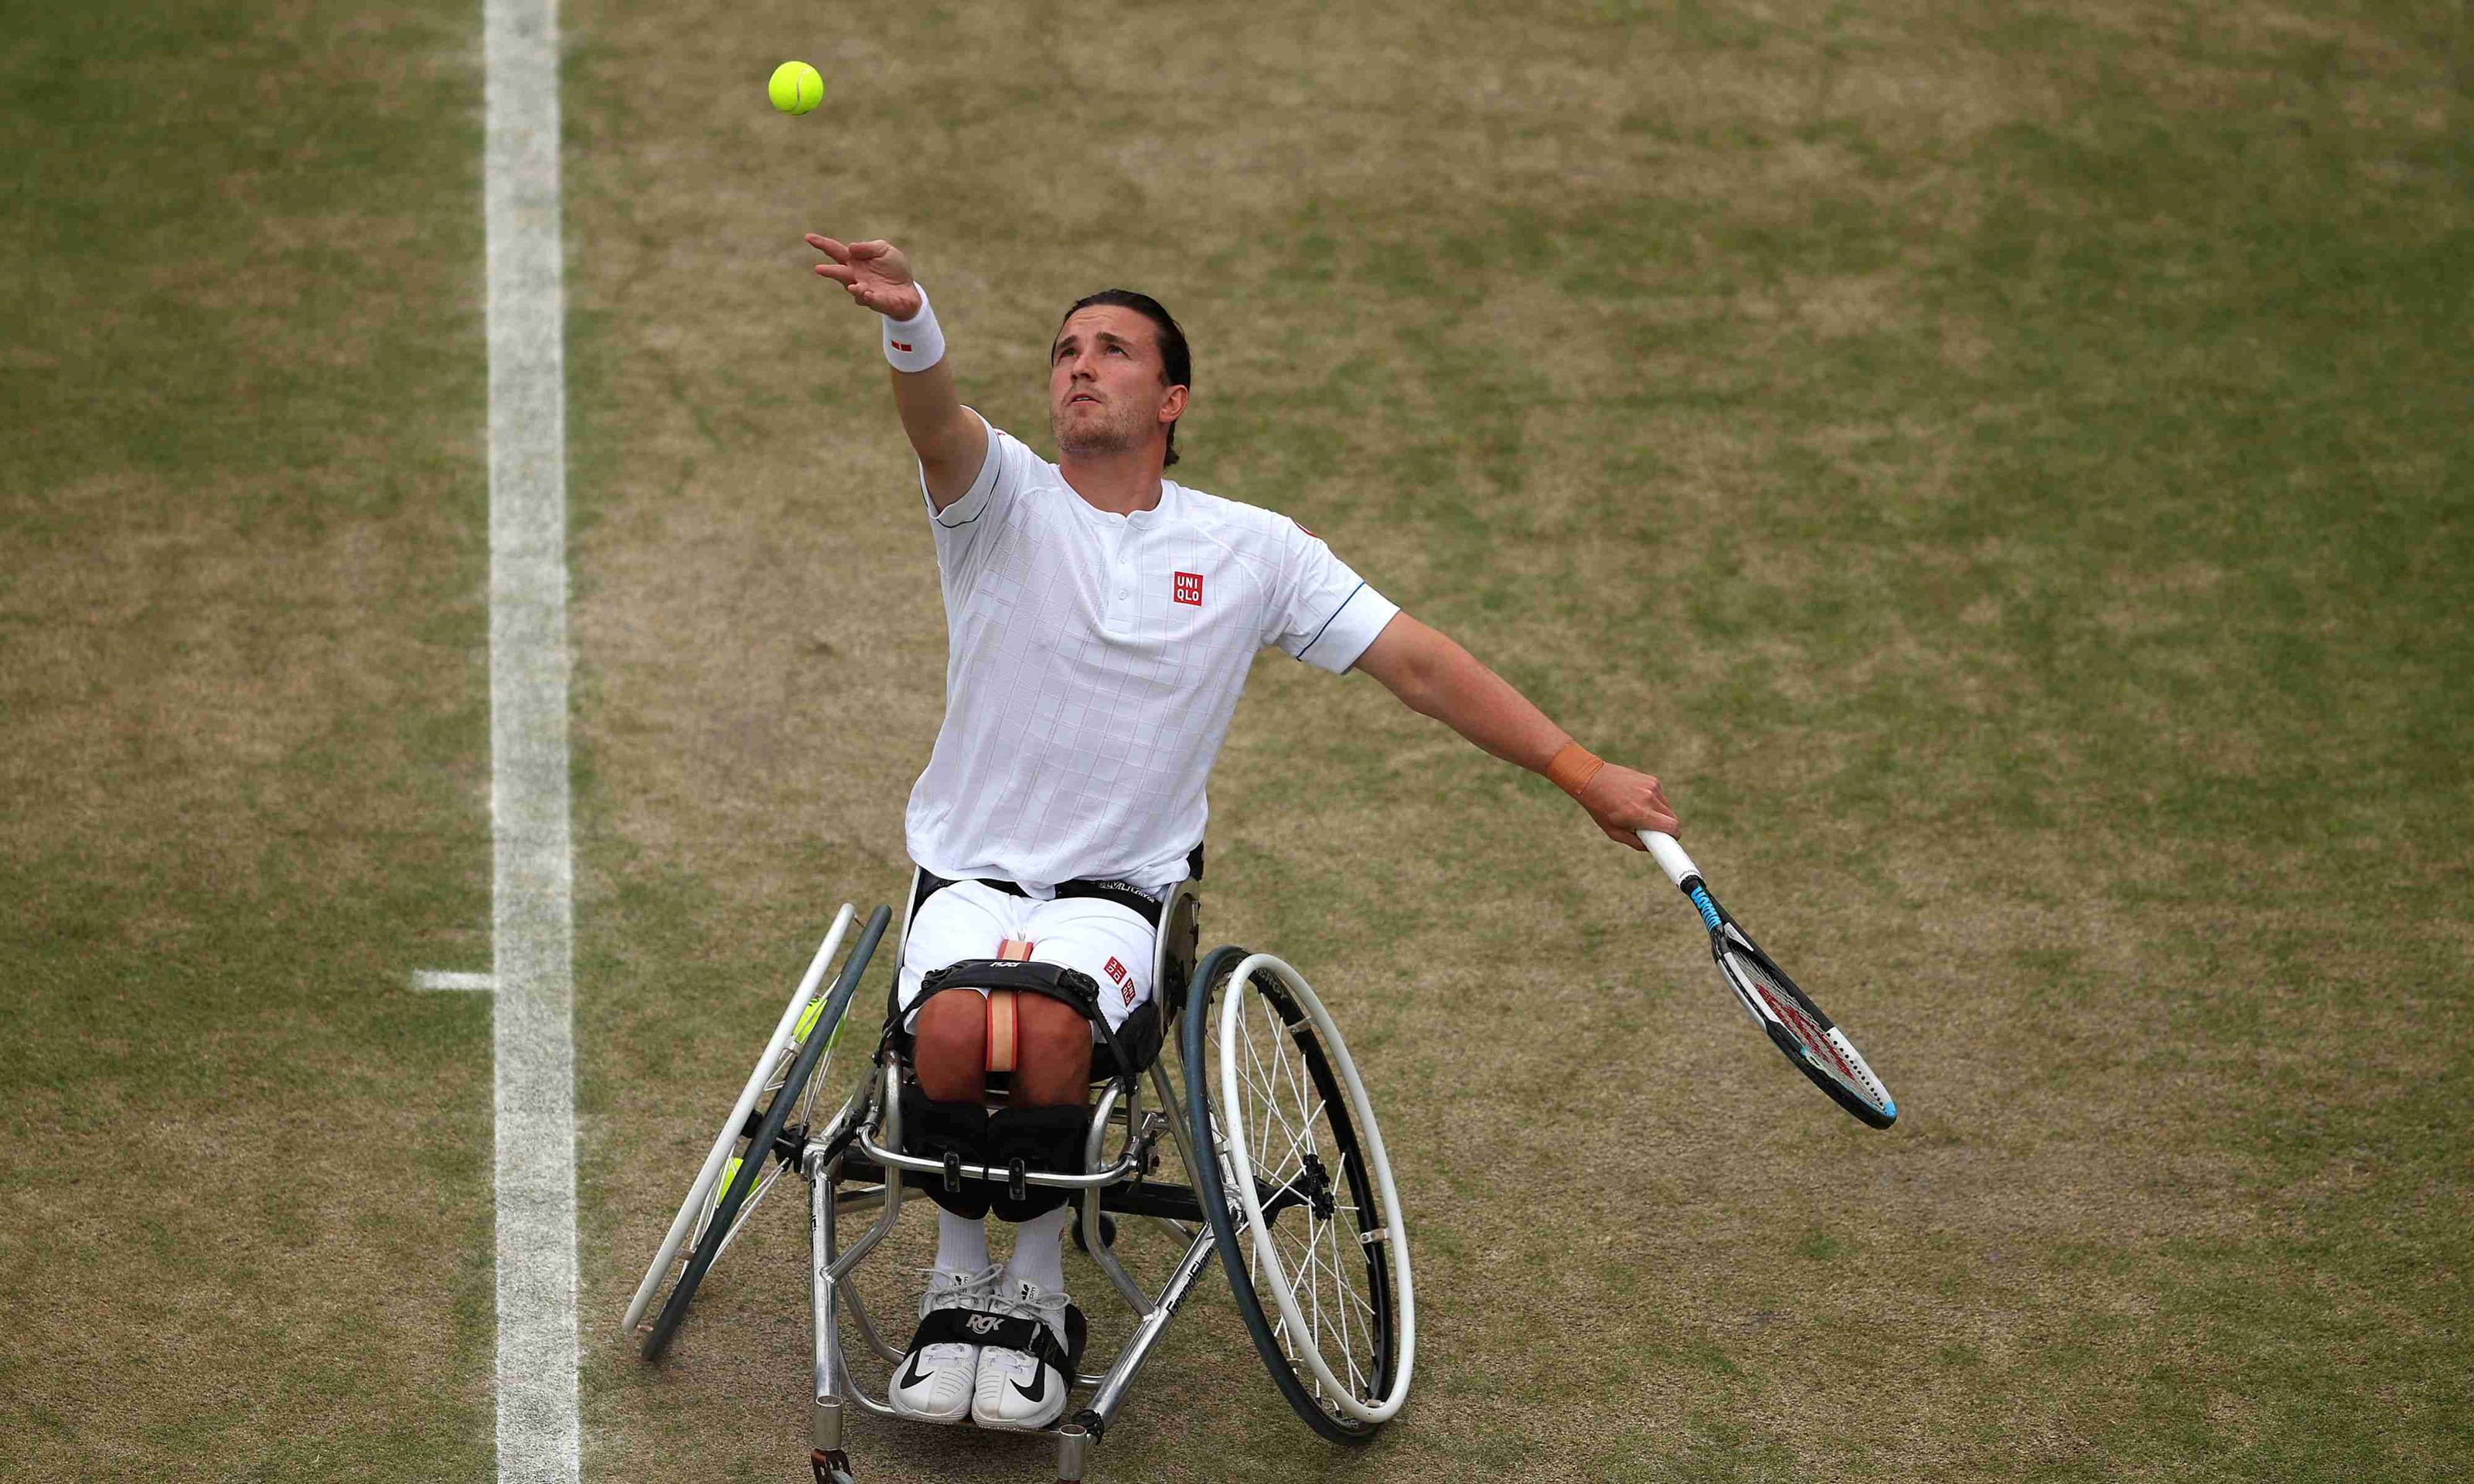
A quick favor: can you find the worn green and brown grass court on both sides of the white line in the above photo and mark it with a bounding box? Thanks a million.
[0,0,2474,1479]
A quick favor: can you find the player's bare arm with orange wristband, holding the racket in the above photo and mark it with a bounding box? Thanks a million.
[1356,614,1680,851]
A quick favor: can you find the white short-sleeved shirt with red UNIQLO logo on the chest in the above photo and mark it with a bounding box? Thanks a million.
[905,415,1400,895]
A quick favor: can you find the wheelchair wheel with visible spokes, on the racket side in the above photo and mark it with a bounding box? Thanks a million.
[1183,948,1418,1442]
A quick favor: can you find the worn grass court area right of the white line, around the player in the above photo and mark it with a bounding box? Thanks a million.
[569,5,2474,1479]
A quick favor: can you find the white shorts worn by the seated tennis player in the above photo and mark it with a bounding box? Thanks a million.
[895,880,1160,1039]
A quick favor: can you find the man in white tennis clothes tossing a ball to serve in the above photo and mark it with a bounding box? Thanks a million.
[806,235,1675,1430]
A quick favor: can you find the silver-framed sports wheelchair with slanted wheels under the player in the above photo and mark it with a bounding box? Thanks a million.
[621,876,1418,1484]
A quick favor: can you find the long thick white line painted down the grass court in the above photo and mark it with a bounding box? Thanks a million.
[482,0,581,1484]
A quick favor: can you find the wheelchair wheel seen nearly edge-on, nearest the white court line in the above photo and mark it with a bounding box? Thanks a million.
[643,907,893,1360]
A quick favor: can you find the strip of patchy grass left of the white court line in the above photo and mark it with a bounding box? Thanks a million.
[0,2,492,1479]
